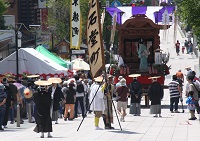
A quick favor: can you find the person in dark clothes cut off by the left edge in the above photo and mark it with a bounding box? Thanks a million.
[0,83,7,131]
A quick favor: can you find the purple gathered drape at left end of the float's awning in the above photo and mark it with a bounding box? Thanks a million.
[106,7,123,25]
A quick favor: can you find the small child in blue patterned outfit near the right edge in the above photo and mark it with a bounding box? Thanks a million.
[186,91,197,120]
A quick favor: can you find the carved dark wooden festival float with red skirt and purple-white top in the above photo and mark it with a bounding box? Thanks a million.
[107,7,174,104]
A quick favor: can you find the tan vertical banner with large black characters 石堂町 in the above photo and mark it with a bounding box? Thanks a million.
[87,0,105,78]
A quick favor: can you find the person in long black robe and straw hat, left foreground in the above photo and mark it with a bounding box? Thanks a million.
[34,81,53,138]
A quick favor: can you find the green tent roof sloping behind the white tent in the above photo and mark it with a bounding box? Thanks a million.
[36,46,67,68]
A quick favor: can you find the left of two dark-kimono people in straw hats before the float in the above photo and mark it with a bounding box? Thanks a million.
[130,76,142,116]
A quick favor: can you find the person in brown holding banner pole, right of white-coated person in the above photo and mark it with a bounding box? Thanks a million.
[103,75,114,129]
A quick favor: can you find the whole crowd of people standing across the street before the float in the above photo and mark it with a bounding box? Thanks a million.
[0,67,200,138]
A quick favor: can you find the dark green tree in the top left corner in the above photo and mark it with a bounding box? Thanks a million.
[0,0,9,29]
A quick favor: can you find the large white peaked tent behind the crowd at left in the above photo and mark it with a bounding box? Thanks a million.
[0,48,68,74]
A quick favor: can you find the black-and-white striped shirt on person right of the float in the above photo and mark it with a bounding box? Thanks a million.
[168,80,180,98]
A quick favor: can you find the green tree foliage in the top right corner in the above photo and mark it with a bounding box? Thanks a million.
[176,0,200,37]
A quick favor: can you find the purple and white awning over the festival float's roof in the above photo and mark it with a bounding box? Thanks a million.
[106,6,175,24]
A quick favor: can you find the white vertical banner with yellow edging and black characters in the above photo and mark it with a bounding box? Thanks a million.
[70,0,82,49]
